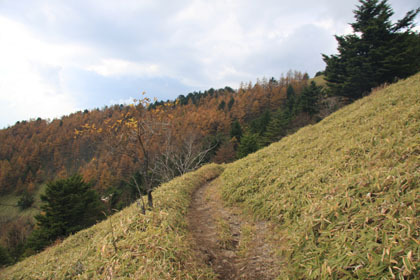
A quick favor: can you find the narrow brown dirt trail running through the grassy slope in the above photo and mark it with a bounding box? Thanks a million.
[188,179,283,279]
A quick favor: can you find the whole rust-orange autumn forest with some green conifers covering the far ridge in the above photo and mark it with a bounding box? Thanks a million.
[0,71,346,257]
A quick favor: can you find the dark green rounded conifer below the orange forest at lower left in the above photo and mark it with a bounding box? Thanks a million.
[28,175,103,251]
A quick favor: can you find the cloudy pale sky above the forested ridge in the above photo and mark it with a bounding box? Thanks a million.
[0,0,419,128]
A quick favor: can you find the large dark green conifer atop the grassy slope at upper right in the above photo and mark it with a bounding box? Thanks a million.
[323,0,420,99]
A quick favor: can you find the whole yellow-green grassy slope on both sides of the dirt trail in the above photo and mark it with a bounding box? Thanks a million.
[0,74,420,279]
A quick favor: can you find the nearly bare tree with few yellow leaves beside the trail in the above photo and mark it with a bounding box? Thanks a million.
[78,95,215,212]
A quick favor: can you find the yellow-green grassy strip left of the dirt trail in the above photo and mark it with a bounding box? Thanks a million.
[0,165,223,279]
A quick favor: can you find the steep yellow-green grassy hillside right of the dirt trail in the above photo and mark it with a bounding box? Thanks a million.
[222,74,420,279]
